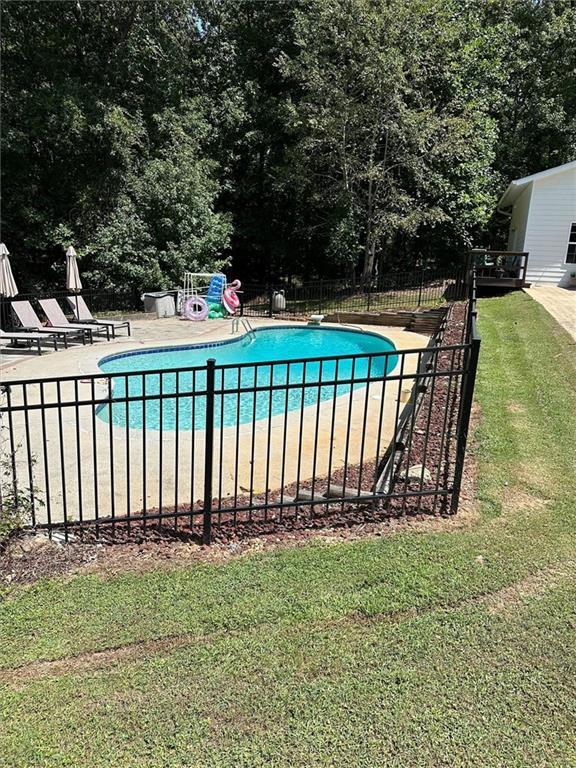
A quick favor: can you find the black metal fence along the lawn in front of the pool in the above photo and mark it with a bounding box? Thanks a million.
[0,268,480,543]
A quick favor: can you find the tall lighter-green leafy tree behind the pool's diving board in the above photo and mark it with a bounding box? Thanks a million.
[283,0,508,280]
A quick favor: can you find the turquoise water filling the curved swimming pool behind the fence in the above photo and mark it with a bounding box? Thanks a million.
[98,326,398,431]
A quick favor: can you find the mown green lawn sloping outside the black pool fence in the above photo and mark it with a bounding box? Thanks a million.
[0,294,576,768]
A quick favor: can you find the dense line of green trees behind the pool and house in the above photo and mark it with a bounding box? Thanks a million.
[2,0,576,289]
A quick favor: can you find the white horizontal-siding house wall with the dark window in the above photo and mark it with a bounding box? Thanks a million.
[515,168,576,285]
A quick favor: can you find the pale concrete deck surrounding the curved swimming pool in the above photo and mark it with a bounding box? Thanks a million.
[0,318,429,522]
